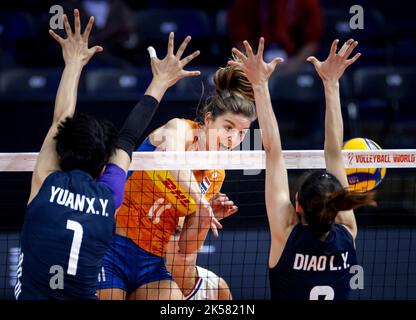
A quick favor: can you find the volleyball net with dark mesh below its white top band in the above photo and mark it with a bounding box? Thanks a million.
[0,149,416,299]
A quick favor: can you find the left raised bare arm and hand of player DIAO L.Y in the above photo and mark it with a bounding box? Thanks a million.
[229,38,296,250]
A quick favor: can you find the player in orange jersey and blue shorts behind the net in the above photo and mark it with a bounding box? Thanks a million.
[98,38,256,300]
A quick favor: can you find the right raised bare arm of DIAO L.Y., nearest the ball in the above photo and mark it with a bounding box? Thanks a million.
[307,39,361,238]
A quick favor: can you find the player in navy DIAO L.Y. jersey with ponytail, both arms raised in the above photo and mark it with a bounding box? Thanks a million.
[230,38,375,300]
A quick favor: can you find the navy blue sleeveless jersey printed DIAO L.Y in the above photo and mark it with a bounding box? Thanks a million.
[269,224,357,300]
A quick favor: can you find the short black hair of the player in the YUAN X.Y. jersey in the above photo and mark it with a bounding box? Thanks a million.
[55,113,118,179]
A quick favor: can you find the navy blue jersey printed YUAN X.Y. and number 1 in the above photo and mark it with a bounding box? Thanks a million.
[15,169,117,300]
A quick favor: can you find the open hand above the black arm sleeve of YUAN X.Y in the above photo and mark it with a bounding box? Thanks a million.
[150,32,201,88]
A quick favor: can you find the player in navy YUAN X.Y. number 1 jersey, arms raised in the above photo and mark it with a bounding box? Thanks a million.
[15,10,198,300]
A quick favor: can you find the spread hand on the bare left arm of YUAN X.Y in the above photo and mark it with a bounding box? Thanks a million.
[49,9,103,67]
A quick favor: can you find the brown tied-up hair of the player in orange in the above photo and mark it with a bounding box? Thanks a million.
[197,58,257,124]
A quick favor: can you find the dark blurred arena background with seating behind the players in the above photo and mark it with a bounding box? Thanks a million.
[0,0,416,299]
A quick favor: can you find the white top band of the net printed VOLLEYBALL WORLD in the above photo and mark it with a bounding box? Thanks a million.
[0,149,416,171]
